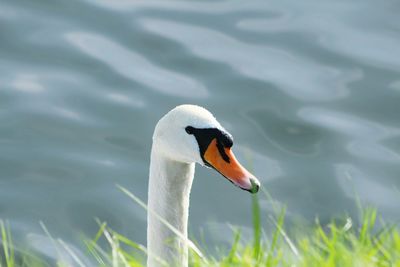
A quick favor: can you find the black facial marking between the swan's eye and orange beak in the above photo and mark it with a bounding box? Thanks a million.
[185,126,233,167]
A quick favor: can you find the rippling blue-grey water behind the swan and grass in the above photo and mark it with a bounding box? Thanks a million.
[0,0,400,260]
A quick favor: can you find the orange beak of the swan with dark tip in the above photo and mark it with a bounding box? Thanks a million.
[204,139,260,193]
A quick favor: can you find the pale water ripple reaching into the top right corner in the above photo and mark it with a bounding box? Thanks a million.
[237,0,400,71]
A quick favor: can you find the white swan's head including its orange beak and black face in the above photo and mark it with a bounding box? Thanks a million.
[153,105,260,193]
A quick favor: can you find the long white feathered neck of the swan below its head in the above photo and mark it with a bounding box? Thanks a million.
[147,149,194,267]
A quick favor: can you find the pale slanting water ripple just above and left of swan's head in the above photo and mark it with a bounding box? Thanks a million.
[65,32,208,98]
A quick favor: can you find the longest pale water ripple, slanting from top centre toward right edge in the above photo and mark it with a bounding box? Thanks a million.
[140,18,362,101]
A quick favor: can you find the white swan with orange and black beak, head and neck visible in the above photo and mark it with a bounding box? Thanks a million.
[147,105,260,267]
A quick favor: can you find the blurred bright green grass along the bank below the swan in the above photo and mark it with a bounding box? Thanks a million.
[0,187,400,267]
